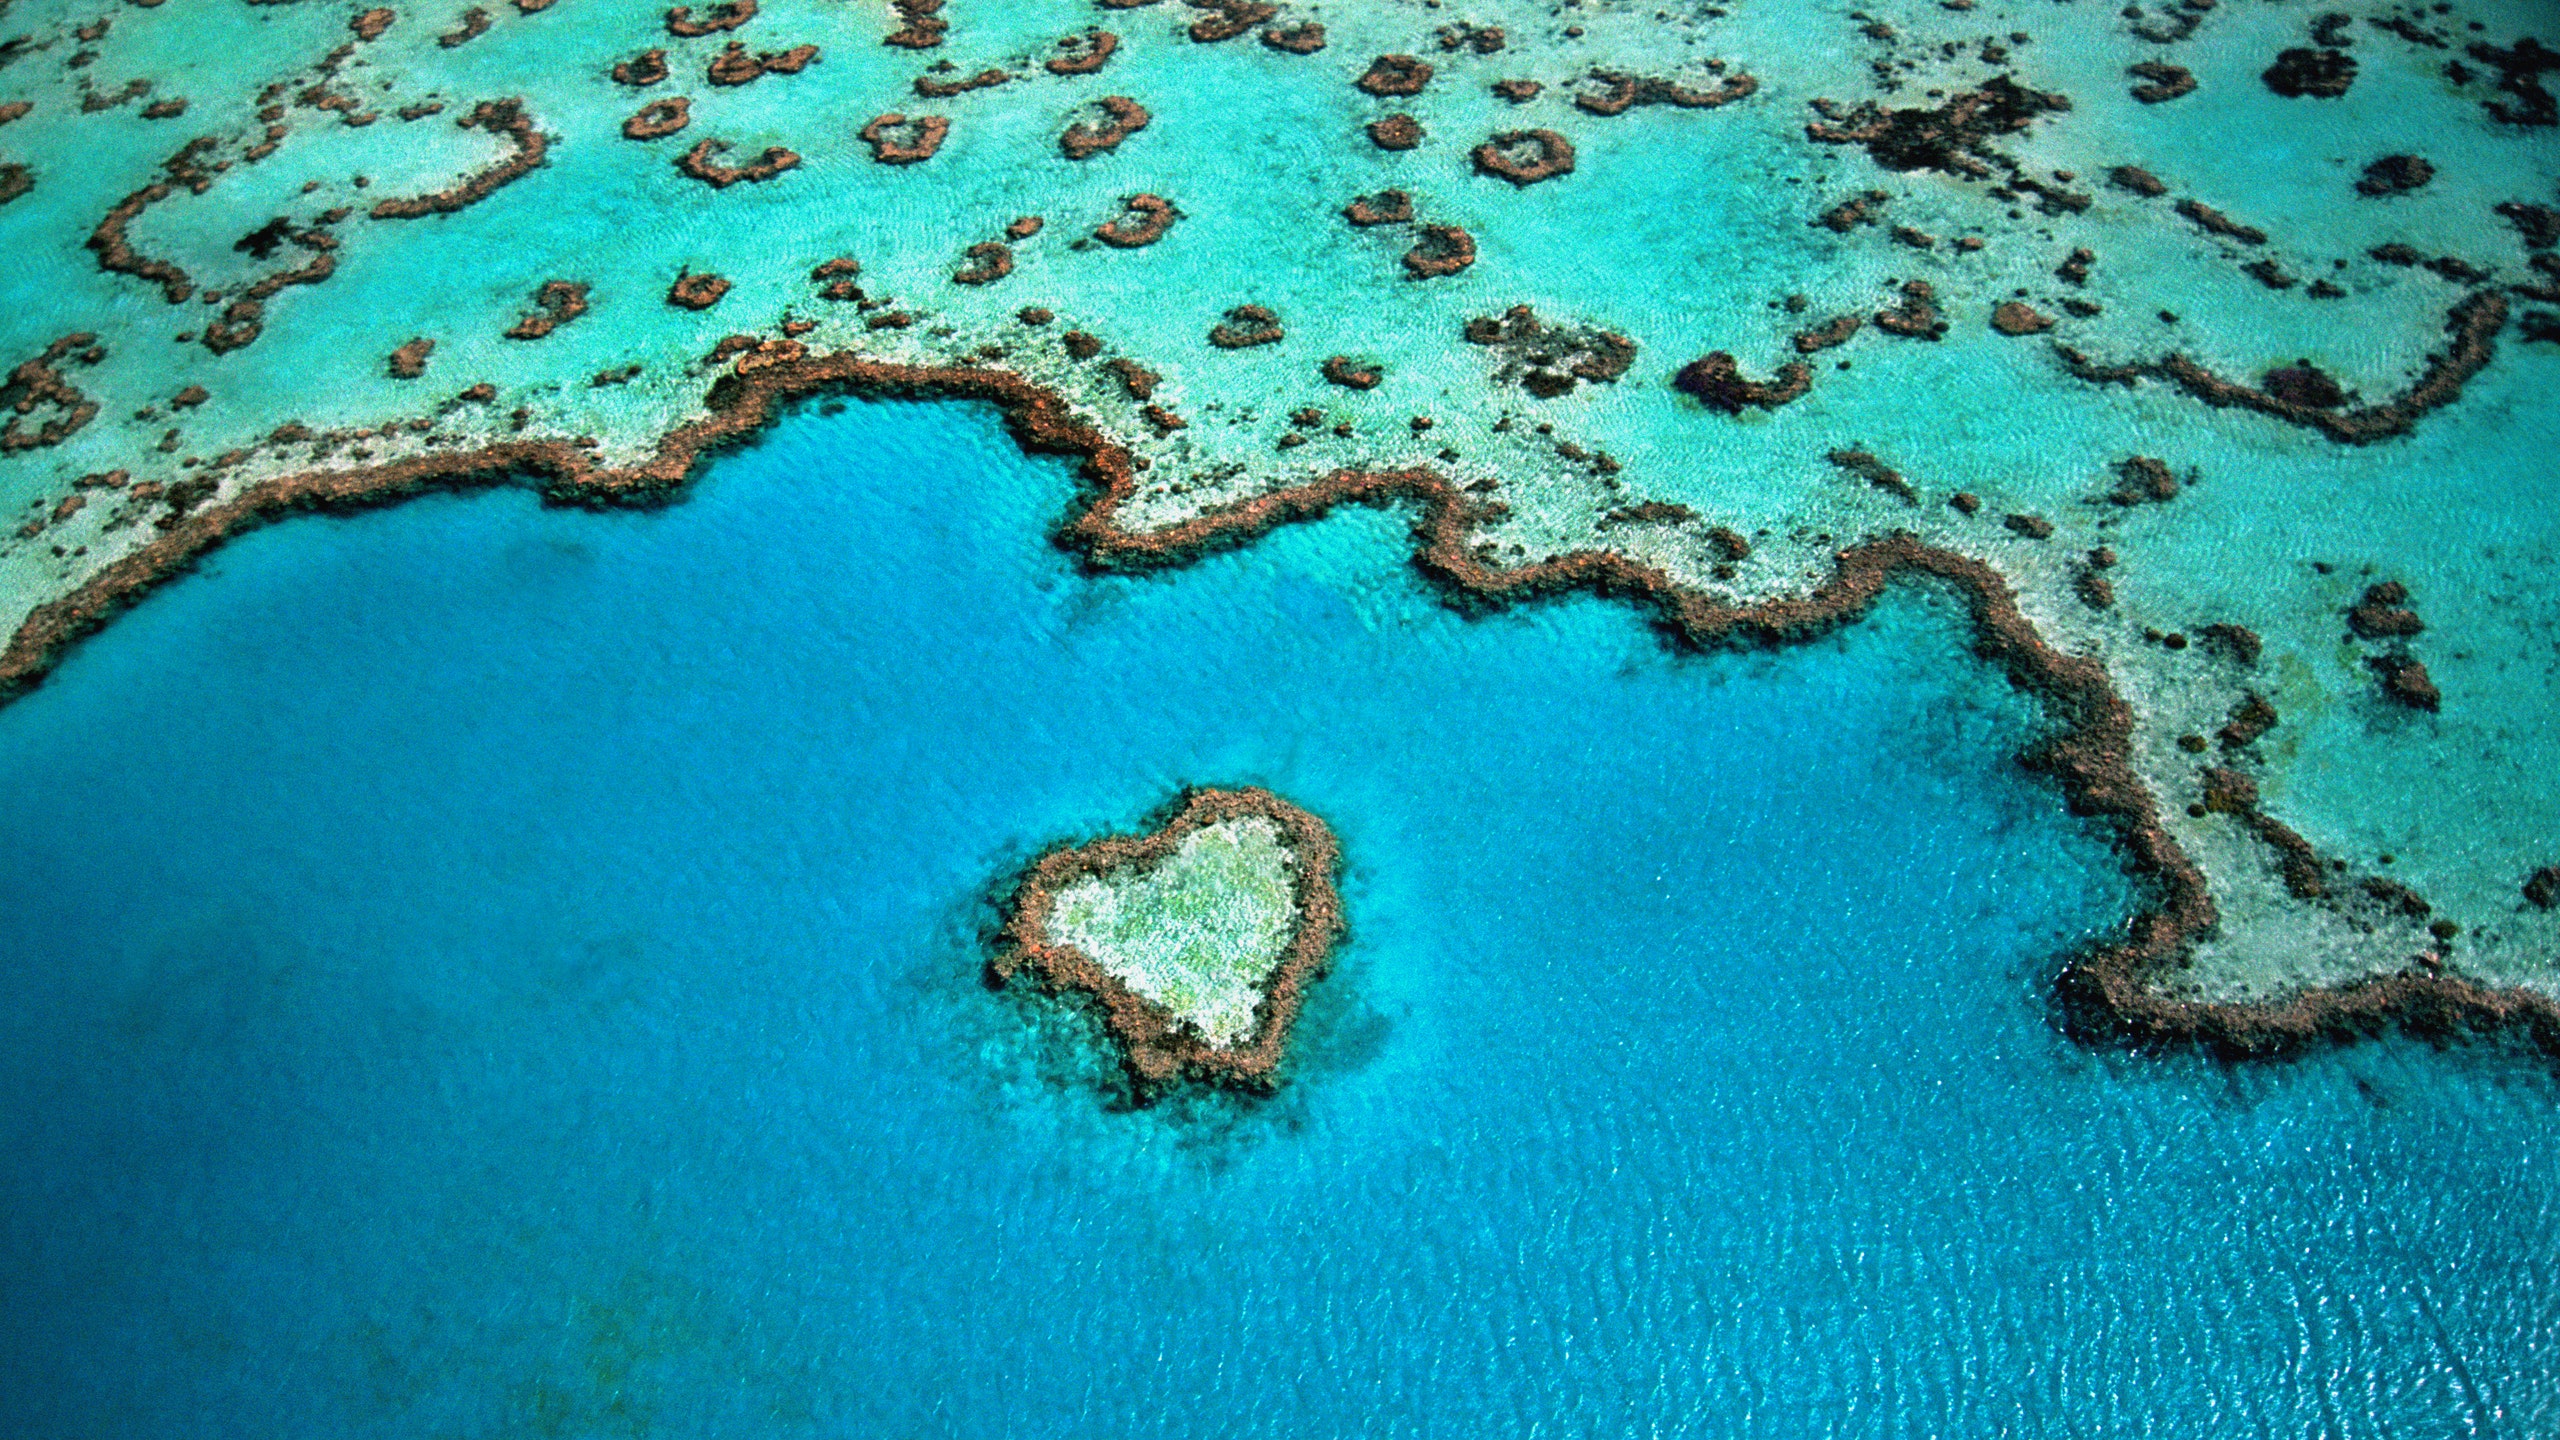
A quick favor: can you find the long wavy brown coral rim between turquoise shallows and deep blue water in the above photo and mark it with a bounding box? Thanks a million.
[0,354,2560,1056]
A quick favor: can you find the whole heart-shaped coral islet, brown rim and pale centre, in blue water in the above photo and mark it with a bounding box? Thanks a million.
[991,789,1341,1089]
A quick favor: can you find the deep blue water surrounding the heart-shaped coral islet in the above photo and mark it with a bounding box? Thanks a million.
[0,394,2560,1440]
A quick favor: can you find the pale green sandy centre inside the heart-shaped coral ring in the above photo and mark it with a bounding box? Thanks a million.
[1050,815,1298,1045]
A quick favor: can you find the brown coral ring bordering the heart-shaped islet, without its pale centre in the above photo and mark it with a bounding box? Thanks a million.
[988,789,1341,1089]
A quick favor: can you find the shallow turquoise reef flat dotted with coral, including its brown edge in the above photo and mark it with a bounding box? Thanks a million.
[0,0,2560,1051]
